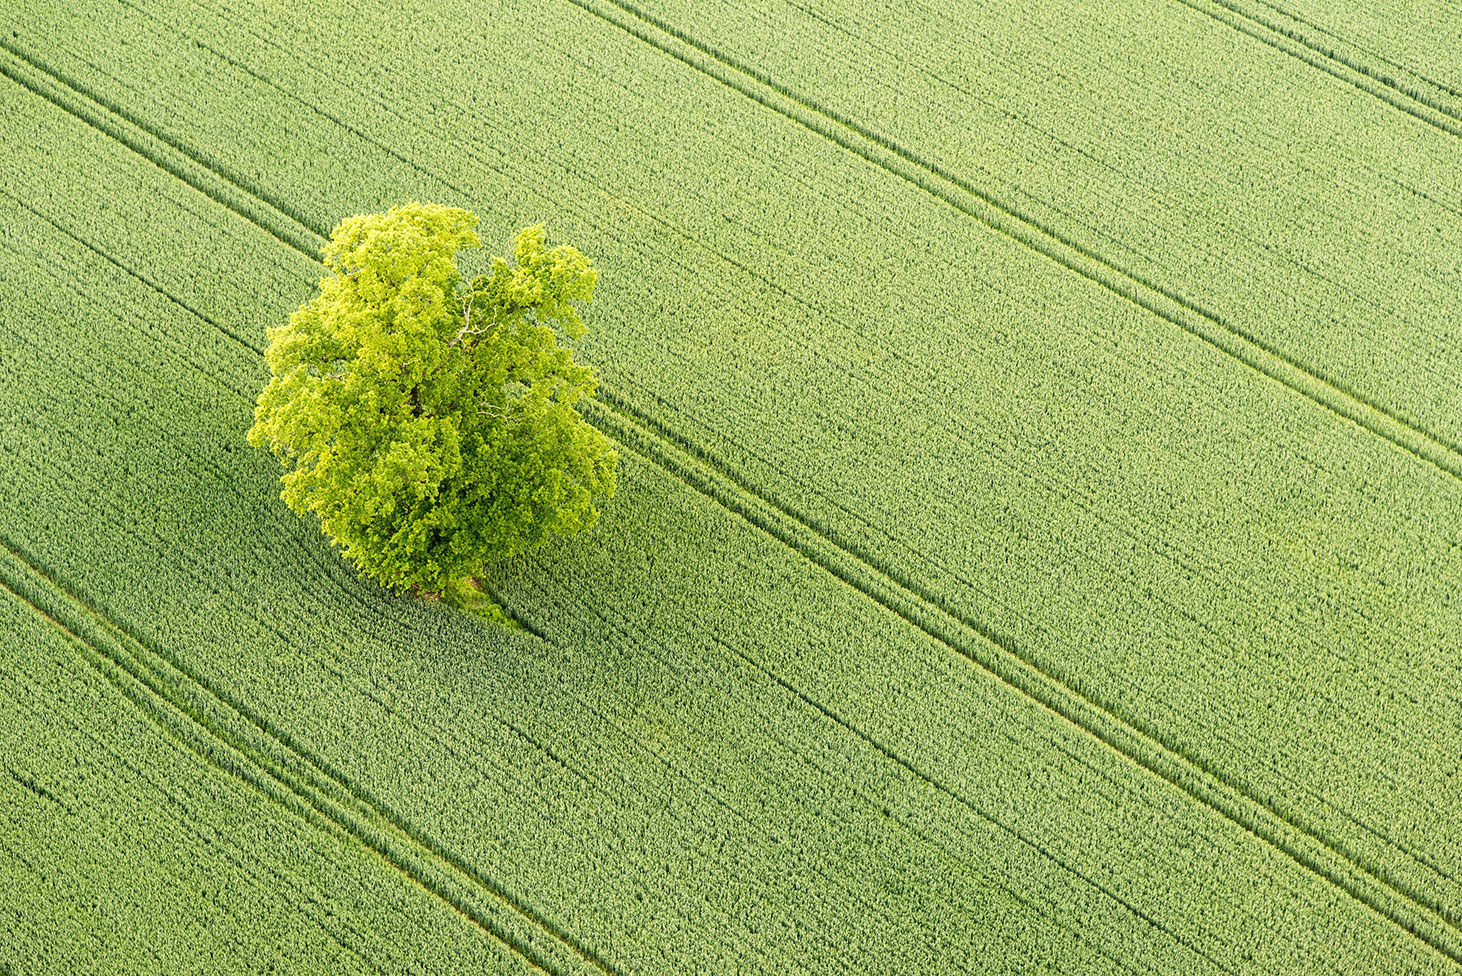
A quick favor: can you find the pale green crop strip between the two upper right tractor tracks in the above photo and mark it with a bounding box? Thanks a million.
[614,0,1462,444]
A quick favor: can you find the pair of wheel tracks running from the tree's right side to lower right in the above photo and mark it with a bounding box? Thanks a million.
[583,390,1462,964]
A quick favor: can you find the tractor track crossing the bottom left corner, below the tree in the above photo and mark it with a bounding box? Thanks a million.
[0,536,620,976]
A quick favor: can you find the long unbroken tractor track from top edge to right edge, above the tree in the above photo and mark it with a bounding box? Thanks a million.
[567,0,1462,479]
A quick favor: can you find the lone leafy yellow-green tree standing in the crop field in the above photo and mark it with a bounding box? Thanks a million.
[249,203,617,621]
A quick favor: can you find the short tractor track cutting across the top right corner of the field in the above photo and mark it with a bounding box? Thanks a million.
[1177,0,1462,136]
